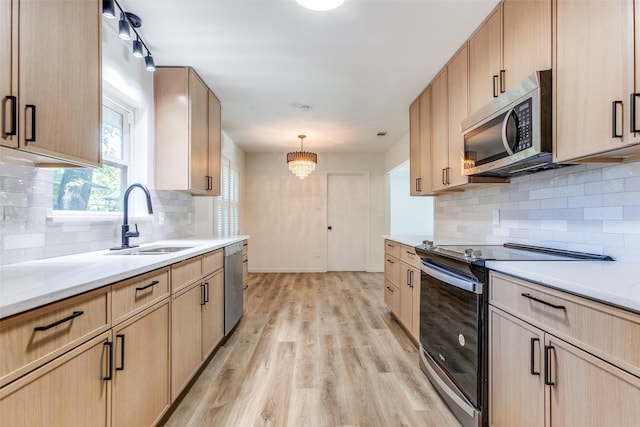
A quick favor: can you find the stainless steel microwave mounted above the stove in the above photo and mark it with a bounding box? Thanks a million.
[460,70,560,177]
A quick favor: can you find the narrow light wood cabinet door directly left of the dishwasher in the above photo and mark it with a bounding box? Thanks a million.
[202,270,224,360]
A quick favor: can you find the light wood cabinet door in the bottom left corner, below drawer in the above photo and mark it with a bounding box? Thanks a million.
[0,332,109,427]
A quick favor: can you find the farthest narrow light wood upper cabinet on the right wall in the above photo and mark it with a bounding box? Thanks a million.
[409,87,431,196]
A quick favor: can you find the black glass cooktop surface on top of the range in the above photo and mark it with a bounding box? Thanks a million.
[416,242,613,264]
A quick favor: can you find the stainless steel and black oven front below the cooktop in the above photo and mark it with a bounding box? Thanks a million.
[420,261,486,427]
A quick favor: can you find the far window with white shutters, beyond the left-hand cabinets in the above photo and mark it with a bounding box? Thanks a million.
[216,157,240,237]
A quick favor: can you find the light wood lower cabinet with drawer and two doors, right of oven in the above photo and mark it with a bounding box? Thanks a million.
[489,275,640,427]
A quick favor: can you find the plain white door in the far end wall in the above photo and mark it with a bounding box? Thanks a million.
[327,172,369,271]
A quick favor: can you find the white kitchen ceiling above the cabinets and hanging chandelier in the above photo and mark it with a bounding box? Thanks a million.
[120,0,498,153]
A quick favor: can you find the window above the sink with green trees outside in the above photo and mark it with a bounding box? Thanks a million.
[53,99,133,212]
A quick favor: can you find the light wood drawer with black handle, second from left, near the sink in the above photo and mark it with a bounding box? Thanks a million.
[111,267,169,325]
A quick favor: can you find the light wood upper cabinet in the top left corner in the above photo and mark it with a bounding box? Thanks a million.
[0,0,102,166]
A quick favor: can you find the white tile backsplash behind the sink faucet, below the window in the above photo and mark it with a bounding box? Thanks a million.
[0,162,195,265]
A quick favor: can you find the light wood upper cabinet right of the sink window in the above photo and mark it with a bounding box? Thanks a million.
[154,67,220,196]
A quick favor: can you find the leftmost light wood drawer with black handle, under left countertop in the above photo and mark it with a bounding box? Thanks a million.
[0,287,111,386]
